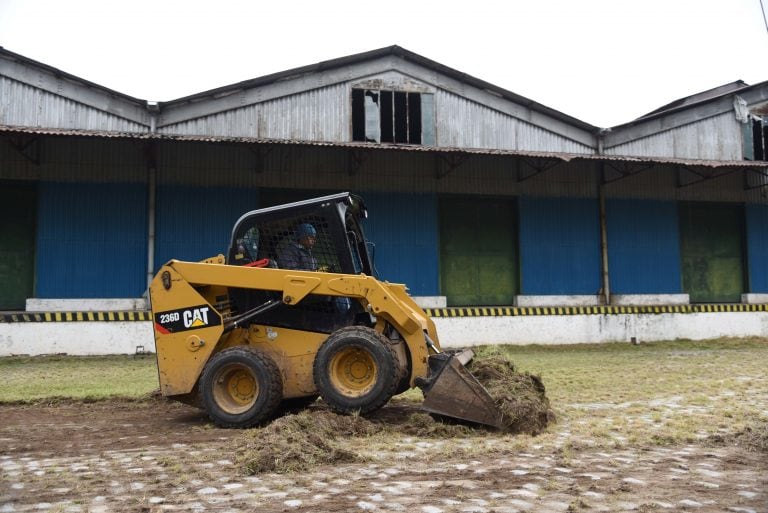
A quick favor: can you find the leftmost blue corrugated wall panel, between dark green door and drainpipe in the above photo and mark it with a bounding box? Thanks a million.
[36,182,147,298]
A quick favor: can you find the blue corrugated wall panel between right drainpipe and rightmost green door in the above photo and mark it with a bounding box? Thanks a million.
[606,199,682,294]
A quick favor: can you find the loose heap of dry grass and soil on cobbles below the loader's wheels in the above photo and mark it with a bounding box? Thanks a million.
[235,410,379,475]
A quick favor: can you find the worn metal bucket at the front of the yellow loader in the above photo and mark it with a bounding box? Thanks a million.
[417,349,503,429]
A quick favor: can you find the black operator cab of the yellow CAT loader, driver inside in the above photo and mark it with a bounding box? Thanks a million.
[227,192,374,333]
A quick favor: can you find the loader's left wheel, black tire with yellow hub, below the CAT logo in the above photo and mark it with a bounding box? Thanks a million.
[200,346,283,428]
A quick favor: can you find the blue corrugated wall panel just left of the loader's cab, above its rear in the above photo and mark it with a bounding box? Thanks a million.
[155,185,259,270]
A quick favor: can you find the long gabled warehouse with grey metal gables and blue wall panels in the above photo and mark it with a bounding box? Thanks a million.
[0,46,768,350]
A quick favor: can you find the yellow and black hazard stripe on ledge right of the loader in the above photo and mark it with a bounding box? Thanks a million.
[425,304,768,318]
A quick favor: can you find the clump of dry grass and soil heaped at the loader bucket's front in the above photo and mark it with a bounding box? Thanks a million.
[467,355,555,435]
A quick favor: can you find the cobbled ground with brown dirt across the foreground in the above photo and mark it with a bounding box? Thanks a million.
[0,400,768,513]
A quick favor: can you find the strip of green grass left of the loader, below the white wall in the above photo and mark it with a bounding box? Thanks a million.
[0,355,158,402]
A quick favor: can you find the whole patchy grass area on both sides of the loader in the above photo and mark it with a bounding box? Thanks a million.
[0,339,768,446]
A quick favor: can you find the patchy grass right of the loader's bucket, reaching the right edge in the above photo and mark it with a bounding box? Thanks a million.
[477,338,768,446]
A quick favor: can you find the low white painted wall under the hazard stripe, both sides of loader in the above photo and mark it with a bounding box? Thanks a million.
[0,312,768,356]
